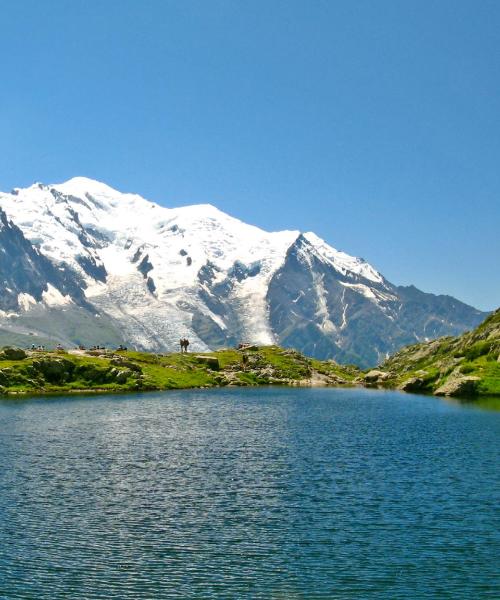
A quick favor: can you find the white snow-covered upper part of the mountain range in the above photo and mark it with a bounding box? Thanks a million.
[0,177,390,314]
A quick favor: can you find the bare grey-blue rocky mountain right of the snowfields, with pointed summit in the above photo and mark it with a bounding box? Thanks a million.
[268,234,485,366]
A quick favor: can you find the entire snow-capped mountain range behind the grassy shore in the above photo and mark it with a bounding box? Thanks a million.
[0,177,485,364]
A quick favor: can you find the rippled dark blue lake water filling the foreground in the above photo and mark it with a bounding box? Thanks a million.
[0,388,500,600]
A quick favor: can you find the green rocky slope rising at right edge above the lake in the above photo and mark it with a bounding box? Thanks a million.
[376,309,500,396]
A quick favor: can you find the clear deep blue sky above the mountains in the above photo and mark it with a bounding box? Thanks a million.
[0,0,500,309]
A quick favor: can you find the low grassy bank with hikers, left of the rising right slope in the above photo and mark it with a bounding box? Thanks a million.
[0,346,352,394]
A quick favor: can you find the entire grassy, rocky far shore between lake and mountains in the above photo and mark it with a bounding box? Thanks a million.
[0,310,500,398]
